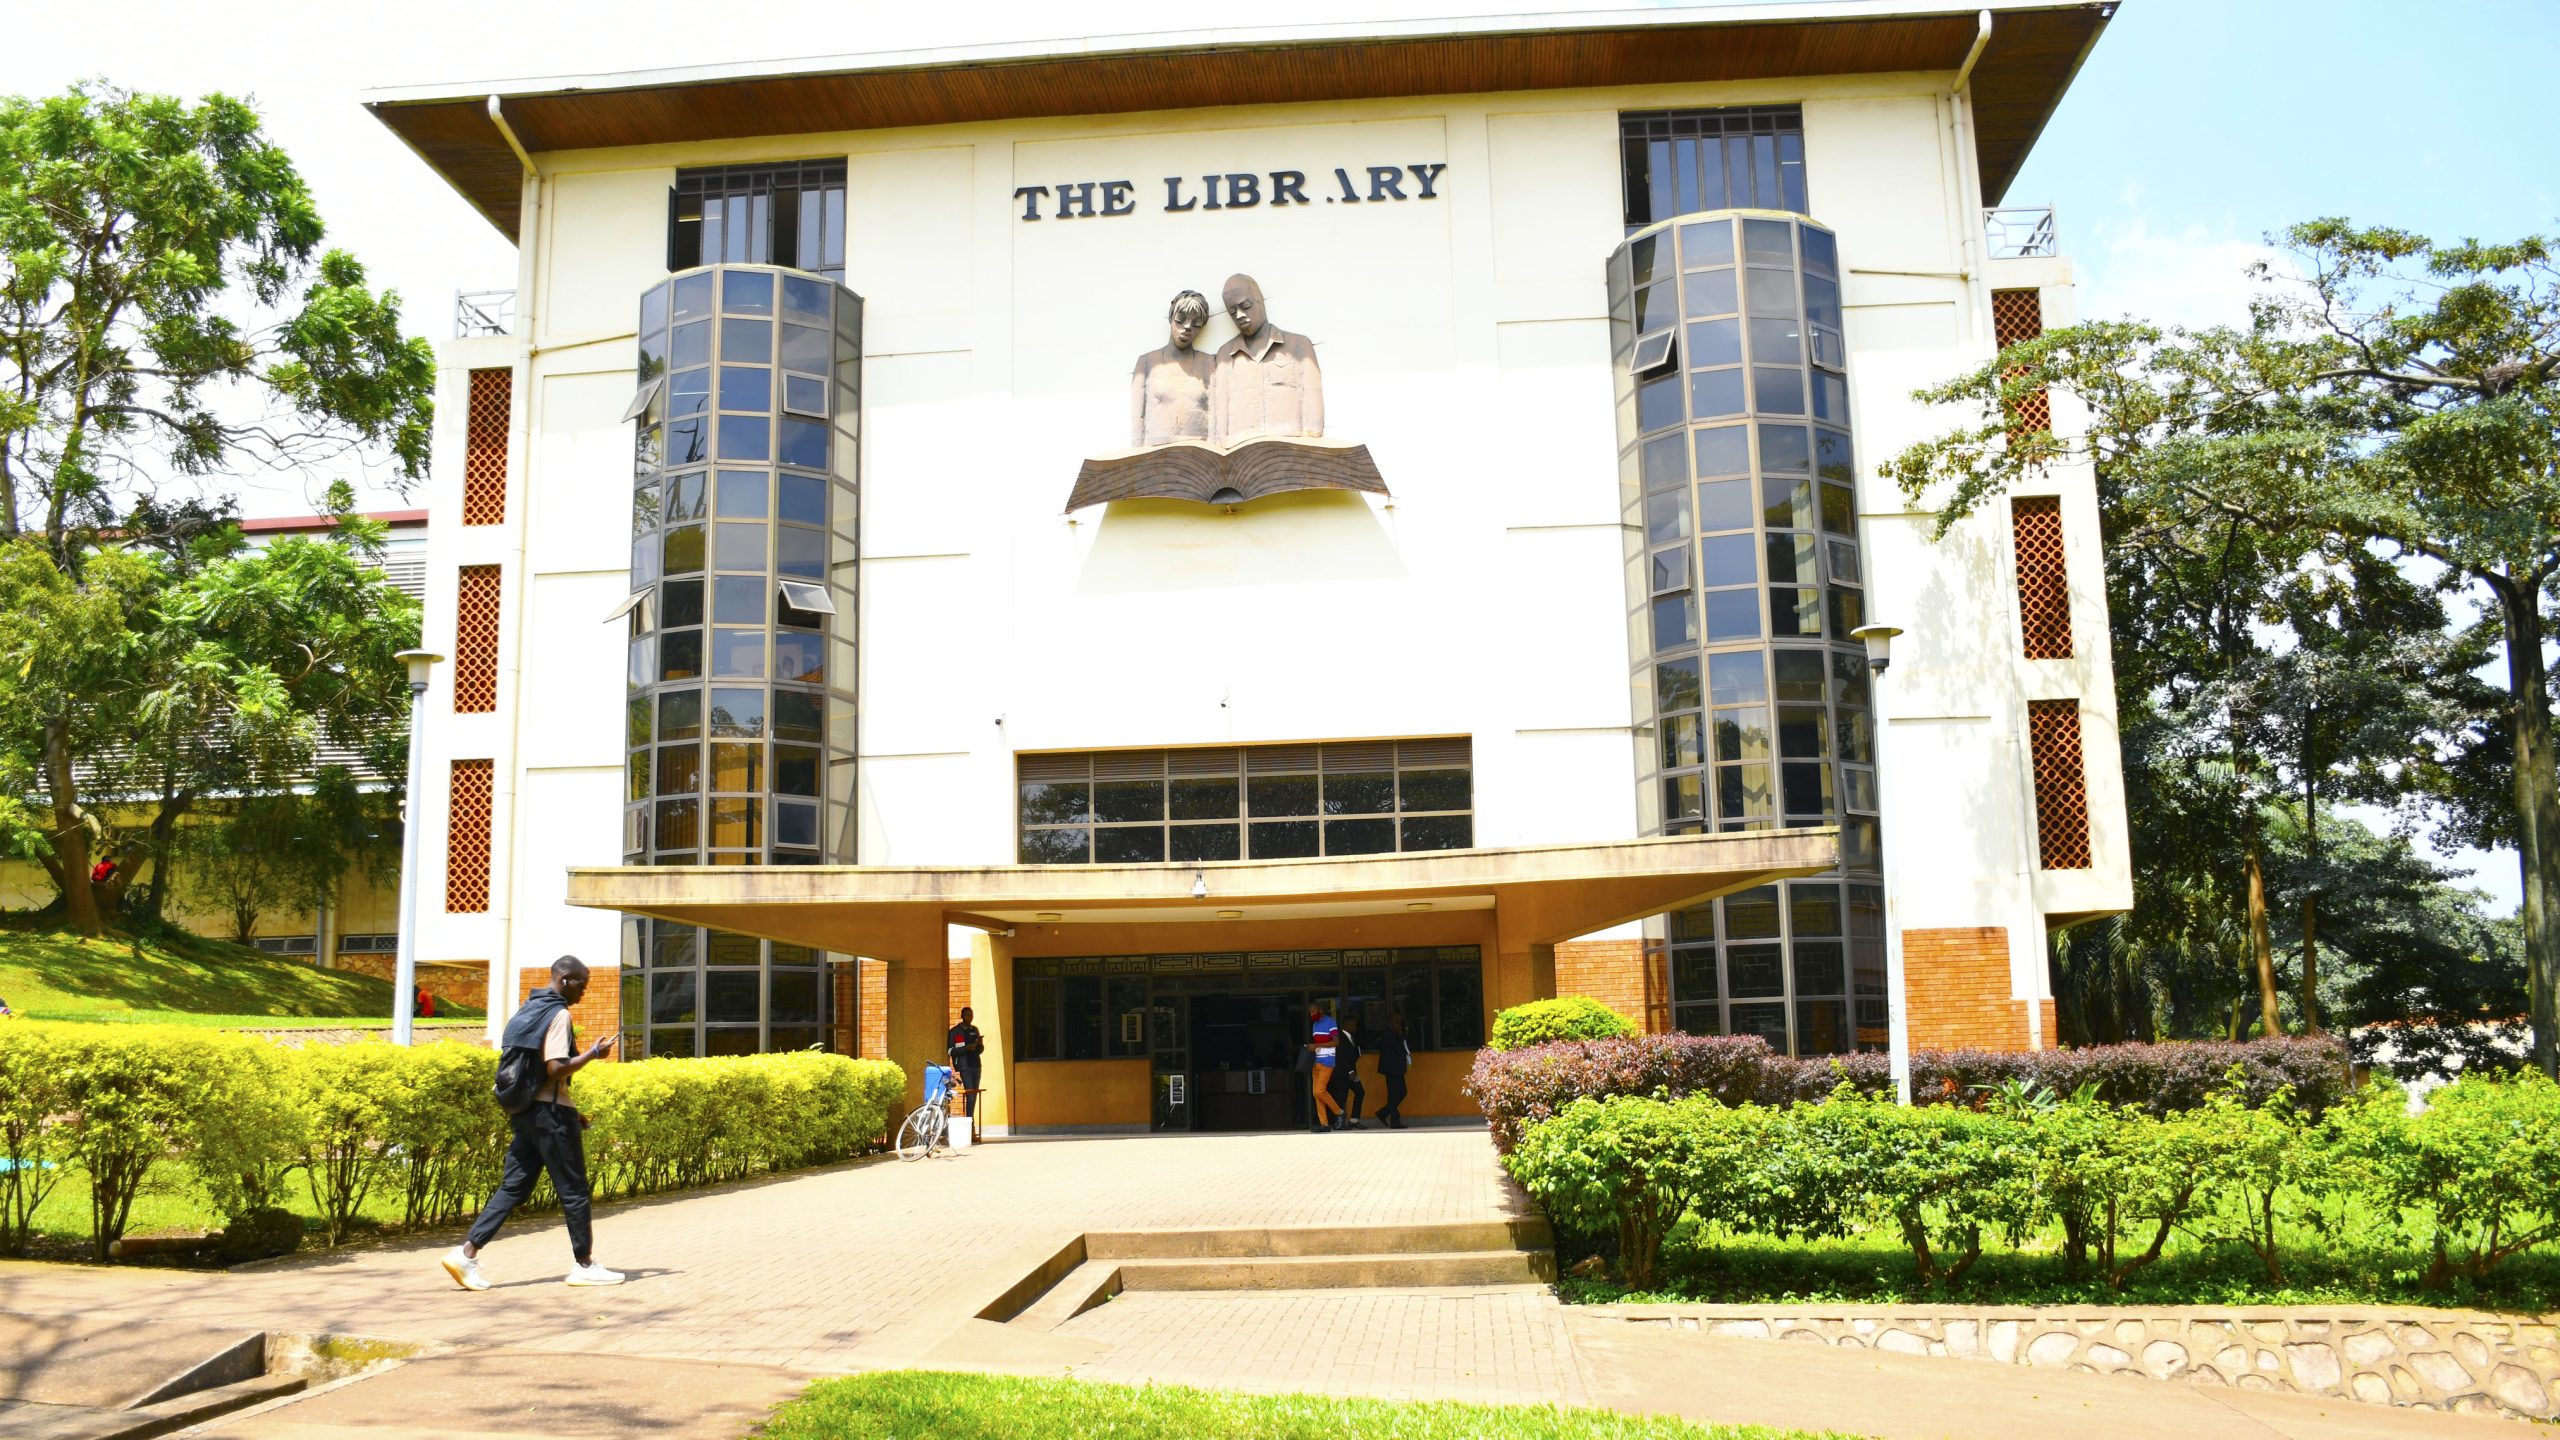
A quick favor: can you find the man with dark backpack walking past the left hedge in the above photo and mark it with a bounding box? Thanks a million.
[445,956,622,1289]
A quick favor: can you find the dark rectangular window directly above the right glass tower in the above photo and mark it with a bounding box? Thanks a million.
[1618,105,1807,233]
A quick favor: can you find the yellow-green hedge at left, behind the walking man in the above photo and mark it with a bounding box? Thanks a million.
[0,1020,906,1258]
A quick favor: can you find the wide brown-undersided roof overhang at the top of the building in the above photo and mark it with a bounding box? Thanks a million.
[366,0,2115,238]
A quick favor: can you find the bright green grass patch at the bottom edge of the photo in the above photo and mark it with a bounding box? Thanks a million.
[763,1371,1863,1440]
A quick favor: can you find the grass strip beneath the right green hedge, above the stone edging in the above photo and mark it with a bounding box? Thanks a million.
[1559,1204,2560,1312]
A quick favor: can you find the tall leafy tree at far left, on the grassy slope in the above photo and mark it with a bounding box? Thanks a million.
[0,85,435,933]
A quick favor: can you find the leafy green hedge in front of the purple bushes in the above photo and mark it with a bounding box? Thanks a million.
[1503,1074,2560,1289]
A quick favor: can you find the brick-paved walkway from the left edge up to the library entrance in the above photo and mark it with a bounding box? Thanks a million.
[0,1130,1526,1371]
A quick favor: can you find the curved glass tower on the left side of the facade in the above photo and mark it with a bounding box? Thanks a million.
[617,264,863,1058]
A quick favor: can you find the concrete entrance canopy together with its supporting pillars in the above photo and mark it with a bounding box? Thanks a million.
[568,825,1841,1117]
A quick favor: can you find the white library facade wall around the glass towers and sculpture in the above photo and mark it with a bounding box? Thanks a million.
[389,8,2130,1043]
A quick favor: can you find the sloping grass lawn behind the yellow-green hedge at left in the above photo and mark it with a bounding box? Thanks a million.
[0,922,479,1027]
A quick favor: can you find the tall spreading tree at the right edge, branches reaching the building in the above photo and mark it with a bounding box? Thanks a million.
[1884,220,2560,1068]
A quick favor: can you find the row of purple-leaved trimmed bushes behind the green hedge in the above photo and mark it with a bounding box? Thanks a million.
[1467,1035,2348,1156]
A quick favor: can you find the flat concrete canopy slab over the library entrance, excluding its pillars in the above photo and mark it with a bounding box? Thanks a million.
[568,825,1841,963]
